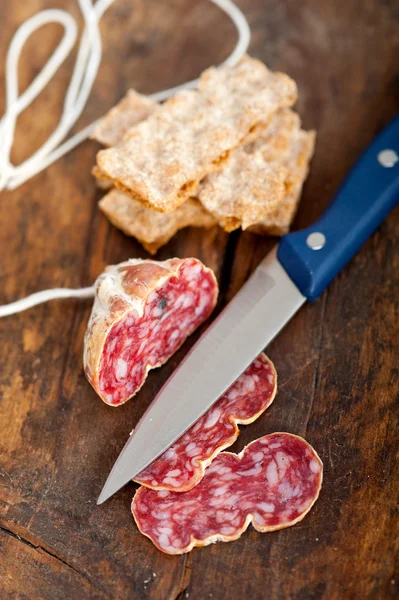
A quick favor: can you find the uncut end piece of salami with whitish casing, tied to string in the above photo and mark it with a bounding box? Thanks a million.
[84,258,218,406]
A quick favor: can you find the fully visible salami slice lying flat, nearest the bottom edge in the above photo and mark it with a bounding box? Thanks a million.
[132,433,323,554]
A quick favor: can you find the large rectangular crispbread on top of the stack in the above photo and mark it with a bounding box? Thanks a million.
[97,57,297,212]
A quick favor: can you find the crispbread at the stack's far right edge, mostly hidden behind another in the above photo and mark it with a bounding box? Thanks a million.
[250,129,316,235]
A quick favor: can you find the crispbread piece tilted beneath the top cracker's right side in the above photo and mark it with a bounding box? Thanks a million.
[198,108,314,233]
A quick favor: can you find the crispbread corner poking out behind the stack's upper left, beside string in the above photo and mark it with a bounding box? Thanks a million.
[90,90,158,146]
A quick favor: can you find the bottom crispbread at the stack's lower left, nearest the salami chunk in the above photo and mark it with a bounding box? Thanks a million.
[99,189,216,254]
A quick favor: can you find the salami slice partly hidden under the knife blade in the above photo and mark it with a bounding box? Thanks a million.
[135,354,277,492]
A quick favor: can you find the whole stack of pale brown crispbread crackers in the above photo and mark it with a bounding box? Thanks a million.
[92,56,315,254]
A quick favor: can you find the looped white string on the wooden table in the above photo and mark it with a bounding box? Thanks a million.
[0,0,251,317]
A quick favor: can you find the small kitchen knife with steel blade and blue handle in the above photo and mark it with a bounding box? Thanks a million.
[97,116,399,504]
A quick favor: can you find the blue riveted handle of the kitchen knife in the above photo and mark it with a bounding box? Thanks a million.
[277,116,399,300]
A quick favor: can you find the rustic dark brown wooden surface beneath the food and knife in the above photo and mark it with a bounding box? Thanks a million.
[0,0,399,600]
